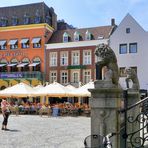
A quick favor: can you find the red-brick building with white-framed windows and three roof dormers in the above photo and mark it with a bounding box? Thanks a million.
[46,19,115,87]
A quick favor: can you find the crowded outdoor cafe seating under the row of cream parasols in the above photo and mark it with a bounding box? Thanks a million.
[0,82,94,116]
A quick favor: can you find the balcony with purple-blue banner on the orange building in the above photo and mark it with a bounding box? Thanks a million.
[0,71,44,80]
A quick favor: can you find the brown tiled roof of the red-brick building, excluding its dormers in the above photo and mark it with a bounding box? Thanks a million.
[48,26,114,44]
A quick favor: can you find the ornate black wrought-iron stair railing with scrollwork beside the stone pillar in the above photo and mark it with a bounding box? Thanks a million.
[120,91,148,148]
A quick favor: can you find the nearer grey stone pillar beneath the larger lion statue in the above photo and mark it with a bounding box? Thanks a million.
[89,80,123,148]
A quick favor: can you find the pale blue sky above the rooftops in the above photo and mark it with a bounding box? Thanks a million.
[0,0,148,31]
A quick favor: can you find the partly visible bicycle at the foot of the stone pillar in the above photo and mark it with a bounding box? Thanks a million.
[84,133,116,148]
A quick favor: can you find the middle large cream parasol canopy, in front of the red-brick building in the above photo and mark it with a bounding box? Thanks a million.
[34,82,69,97]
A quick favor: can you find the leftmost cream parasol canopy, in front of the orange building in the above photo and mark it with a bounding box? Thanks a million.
[0,82,35,97]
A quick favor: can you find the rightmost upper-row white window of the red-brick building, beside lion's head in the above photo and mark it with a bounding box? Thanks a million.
[83,50,91,65]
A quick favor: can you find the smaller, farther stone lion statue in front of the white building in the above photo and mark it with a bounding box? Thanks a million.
[125,67,140,90]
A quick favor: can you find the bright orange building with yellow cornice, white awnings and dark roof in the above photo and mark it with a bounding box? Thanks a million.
[0,3,57,89]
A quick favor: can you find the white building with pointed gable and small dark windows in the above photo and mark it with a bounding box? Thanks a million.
[110,14,148,90]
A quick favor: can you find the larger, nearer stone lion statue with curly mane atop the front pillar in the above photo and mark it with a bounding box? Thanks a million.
[95,44,119,85]
